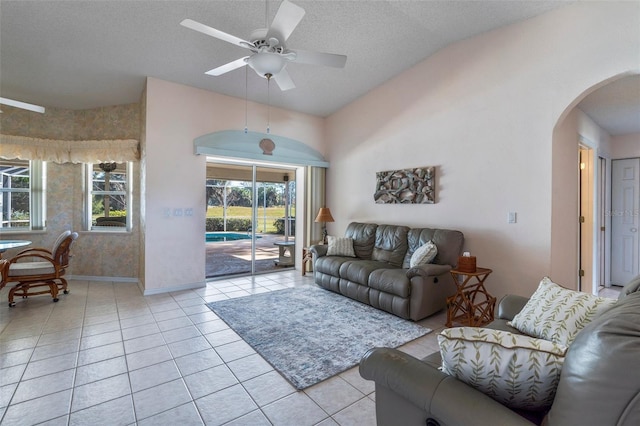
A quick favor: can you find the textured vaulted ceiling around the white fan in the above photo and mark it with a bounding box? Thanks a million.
[0,0,640,131]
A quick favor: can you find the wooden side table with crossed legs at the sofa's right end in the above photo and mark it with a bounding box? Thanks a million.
[446,268,496,327]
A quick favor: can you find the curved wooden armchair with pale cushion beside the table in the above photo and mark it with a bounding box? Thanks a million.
[0,231,78,307]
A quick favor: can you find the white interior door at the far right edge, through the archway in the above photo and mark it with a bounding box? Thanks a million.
[611,158,640,285]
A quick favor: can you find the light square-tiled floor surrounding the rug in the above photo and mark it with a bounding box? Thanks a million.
[0,271,446,426]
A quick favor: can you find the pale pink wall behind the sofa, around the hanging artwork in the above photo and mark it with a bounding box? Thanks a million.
[327,2,640,296]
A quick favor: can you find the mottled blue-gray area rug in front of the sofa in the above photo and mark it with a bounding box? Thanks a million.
[207,286,431,389]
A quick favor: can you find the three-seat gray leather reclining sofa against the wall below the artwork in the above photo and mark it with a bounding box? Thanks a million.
[310,222,464,321]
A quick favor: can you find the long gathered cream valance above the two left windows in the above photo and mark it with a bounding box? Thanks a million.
[0,135,140,163]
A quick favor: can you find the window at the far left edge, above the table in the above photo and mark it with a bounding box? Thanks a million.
[0,159,46,231]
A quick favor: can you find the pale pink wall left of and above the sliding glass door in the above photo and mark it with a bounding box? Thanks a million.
[141,78,324,294]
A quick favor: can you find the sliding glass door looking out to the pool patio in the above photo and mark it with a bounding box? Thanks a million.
[205,161,296,278]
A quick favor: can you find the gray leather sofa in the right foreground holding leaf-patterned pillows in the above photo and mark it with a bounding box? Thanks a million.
[360,277,640,426]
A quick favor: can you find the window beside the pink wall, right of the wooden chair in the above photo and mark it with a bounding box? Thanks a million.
[86,162,132,231]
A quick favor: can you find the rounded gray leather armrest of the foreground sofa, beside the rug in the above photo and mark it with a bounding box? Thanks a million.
[359,348,533,426]
